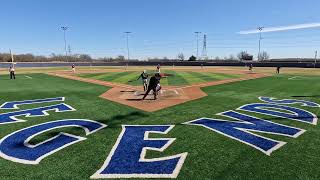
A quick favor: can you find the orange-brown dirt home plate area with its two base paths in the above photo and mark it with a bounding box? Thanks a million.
[48,72,269,112]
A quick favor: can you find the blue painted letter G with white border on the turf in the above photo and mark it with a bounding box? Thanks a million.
[0,119,106,164]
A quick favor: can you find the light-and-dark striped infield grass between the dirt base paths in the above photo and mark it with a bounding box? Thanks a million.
[78,70,242,86]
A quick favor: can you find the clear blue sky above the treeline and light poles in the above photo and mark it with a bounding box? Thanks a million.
[0,0,320,59]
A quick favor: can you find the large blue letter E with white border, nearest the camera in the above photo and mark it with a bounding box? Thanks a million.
[91,125,187,178]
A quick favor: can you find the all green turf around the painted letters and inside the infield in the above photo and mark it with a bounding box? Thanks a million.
[0,71,320,180]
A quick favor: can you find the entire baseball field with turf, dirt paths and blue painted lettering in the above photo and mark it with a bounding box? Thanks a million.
[0,67,320,180]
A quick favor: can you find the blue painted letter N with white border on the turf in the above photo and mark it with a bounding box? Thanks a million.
[184,111,305,155]
